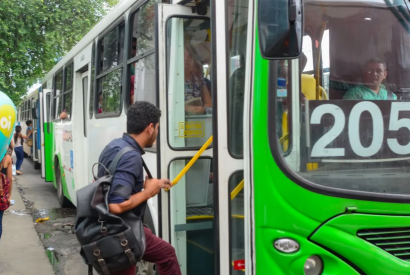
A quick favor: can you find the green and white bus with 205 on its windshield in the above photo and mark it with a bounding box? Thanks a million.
[38,0,410,275]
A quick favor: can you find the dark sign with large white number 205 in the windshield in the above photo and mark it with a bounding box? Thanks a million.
[307,100,410,159]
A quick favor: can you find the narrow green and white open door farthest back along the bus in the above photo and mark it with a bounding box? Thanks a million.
[41,89,54,181]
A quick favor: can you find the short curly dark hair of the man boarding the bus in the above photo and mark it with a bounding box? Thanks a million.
[127,101,161,135]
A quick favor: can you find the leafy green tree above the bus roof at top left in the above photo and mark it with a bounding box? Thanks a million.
[0,0,119,106]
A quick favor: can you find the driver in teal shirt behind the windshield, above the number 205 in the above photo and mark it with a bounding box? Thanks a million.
[343,58,397,100]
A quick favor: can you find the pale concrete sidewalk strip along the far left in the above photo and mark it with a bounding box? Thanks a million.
[0,178,55,275]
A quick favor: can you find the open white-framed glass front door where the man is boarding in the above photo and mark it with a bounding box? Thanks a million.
[156,4,219,275]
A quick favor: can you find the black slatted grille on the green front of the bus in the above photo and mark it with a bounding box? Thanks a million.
[357,227,410,262]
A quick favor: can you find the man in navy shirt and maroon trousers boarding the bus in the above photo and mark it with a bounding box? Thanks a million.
[98,101,181,275]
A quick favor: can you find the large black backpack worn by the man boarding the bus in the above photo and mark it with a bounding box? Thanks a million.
[74,147,148,275]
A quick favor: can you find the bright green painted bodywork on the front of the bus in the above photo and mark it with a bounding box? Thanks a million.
[252,15,410,275]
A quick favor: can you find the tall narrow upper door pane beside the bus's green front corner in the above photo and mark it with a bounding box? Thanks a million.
[226,0,248,158]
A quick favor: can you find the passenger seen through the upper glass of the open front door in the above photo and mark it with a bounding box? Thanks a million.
[184,43,212,114]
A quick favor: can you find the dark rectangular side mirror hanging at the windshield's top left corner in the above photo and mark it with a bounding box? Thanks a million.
[258,0,303,59]
